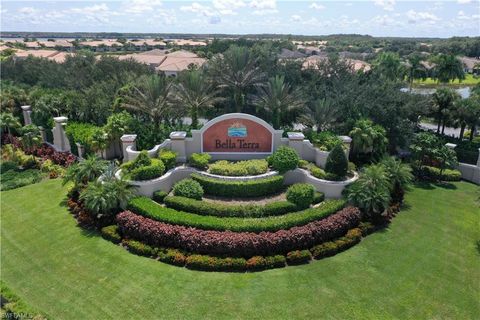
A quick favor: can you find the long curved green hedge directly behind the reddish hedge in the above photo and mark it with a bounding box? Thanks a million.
[128,197,345,233]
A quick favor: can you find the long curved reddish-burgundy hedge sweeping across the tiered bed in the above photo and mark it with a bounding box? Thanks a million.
[117,207,360,257]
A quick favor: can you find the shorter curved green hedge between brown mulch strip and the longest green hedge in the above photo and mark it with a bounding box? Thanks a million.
[163,196,299,218]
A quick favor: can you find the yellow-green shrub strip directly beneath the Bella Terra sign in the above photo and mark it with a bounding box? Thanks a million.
[208,159,268,176]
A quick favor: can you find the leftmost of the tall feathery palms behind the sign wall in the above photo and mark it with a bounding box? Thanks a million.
[120,75,172,127]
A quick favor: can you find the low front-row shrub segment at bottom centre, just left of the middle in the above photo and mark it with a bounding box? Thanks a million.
[185,254,246,271]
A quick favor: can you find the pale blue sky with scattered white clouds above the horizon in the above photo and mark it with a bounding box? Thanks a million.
[0,0,480,37]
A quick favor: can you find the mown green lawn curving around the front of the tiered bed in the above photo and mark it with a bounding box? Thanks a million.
[0,180,480,319]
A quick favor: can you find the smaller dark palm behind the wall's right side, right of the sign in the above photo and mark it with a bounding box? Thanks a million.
[299,98,340,132]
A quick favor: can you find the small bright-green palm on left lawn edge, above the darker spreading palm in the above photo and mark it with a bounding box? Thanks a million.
[63,156,108,186]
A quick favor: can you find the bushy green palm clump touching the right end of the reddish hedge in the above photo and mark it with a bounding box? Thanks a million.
[345,164,392,221]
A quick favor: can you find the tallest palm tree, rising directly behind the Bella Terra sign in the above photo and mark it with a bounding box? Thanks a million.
[209,45,265,112]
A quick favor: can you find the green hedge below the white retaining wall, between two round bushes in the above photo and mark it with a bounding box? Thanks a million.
[191,173,284,197]
